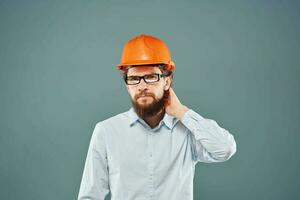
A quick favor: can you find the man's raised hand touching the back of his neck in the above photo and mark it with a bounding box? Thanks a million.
[165,88,188,120]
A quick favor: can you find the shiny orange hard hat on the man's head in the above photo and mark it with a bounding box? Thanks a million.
[117,34,175,71]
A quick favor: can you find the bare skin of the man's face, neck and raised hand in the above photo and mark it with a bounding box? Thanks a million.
[126,66,188,128]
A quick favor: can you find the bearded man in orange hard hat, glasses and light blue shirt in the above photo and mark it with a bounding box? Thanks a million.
[78,34,236,200]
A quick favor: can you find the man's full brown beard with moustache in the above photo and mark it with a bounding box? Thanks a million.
[131,90,170,119]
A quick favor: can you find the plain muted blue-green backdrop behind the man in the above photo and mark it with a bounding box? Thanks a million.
[0,0,300,200]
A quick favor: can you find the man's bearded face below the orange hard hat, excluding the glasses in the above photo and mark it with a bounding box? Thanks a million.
[127,66,171,118]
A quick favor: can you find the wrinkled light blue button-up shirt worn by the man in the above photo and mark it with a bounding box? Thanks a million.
[78,108,236,200]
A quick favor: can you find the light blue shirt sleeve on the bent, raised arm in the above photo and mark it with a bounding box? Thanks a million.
[181,109,236,163]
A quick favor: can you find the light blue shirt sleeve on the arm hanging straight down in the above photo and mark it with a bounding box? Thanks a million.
[78,123,109,200]
